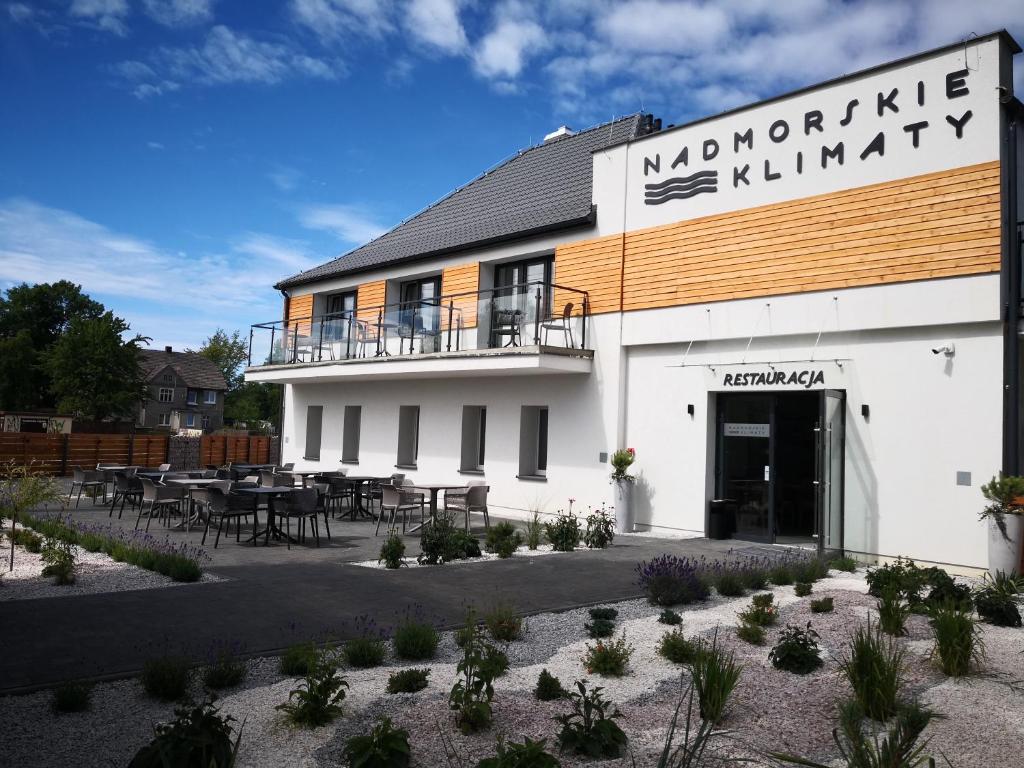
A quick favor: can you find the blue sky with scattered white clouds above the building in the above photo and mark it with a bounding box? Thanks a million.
[0,0,1024,348]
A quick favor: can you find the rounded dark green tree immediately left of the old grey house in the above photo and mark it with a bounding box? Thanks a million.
[45,312,150,421]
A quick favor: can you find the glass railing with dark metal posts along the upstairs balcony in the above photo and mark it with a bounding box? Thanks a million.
[249,283,590,367]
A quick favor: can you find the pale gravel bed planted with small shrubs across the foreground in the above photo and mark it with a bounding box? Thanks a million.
[0,572,1024,768]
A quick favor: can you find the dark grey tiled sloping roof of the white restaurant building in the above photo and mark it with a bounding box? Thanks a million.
[275,115,640,288]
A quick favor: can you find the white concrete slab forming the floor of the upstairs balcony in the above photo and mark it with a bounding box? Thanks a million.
[246,345,594,384]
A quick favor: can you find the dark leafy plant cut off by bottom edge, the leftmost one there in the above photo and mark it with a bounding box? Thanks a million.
[128,699,242,768]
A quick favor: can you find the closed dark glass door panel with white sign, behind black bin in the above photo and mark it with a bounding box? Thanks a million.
[717,394,775,542]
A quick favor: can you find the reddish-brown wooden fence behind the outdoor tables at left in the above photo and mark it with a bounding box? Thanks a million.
[0,432,270,475]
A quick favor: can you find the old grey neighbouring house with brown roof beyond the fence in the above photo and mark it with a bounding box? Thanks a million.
[137,347,227,432]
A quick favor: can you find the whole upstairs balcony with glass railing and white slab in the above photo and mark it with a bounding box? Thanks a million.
[246,283,594,383]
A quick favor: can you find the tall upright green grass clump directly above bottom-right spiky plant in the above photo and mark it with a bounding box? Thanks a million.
[840,620,904,722]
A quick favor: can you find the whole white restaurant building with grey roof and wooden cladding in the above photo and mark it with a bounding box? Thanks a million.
[247,33,1024,567]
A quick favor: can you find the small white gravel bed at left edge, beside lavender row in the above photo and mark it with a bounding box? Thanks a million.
[0,538,221,602]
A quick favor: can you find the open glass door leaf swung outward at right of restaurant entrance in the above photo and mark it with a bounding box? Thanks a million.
[814,389,846,553]
